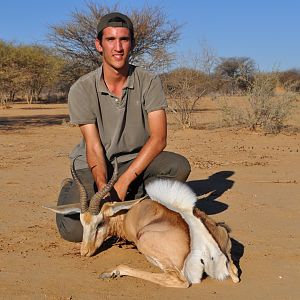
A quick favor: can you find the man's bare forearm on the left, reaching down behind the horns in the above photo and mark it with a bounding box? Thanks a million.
[80,124,107,190]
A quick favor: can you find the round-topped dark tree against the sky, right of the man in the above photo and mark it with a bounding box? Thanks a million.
[215,57,256,94]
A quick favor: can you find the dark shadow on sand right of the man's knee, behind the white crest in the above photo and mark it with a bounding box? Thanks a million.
[187,171,234,215]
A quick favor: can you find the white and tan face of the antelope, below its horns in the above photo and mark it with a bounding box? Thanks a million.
[80,212,107,256]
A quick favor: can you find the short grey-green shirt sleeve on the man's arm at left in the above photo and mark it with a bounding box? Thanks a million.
[68,82,96,124]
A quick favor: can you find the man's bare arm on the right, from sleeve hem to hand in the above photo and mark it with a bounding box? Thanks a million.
[114,110,167,201]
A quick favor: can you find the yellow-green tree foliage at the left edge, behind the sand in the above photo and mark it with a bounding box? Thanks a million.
[0,41,64,105]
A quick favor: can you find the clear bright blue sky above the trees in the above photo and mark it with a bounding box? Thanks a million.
[0,0,300,71]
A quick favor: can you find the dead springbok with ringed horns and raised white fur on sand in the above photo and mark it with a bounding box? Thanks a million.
[46,161,239,288]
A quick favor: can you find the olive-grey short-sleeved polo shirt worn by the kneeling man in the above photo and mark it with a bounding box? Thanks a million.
[68,65,167,169]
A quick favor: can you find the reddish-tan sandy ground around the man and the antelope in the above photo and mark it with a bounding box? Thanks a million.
[0,103,300,300]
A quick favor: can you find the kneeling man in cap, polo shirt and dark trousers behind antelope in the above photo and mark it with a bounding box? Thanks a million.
[56,12,190,242]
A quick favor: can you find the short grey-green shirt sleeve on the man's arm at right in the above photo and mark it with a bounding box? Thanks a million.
[144,76,168,113]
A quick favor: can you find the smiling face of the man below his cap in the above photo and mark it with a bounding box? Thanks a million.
[96,27,132,71]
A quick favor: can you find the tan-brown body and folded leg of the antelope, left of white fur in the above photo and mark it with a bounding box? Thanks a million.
[96,199,190,288]
